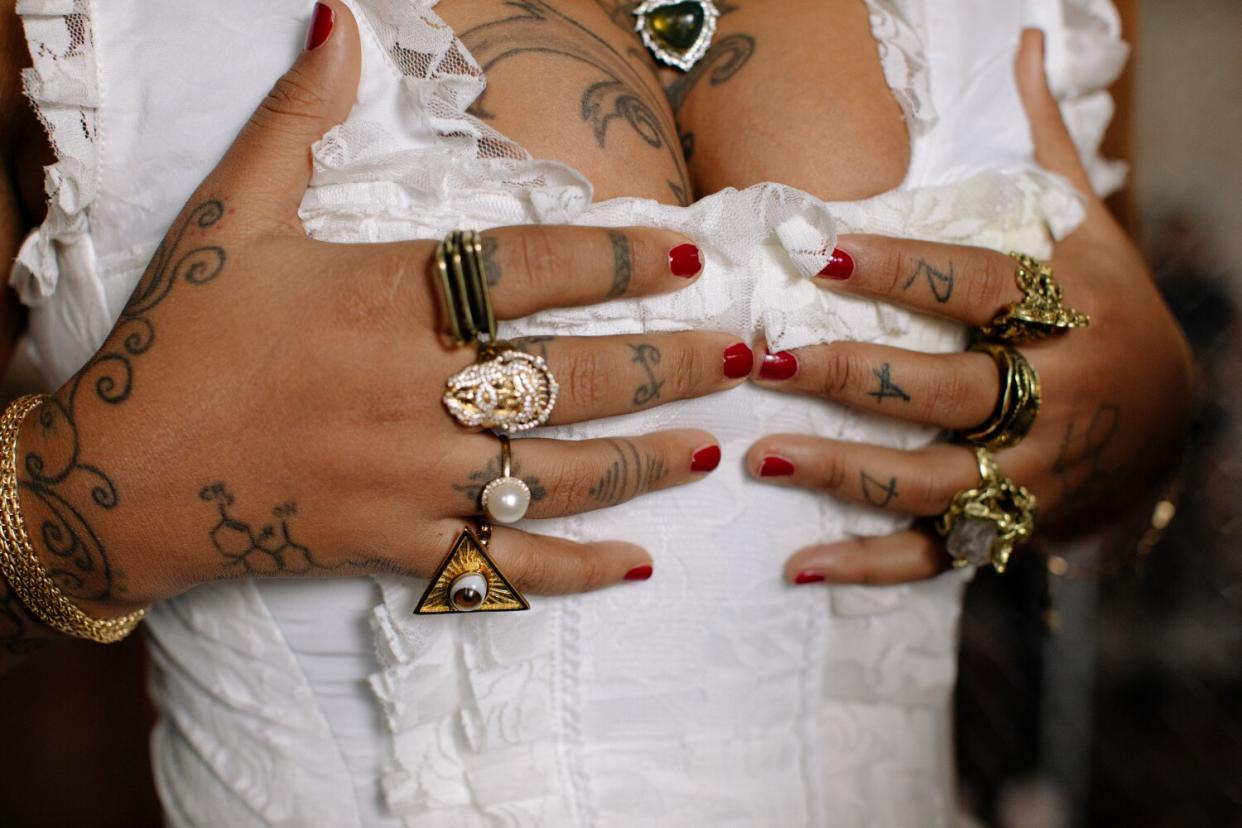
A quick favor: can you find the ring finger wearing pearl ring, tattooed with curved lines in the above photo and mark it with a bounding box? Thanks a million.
[451,430,720,518]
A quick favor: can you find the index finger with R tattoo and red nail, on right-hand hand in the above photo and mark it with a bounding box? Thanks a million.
[815,233,1022,326]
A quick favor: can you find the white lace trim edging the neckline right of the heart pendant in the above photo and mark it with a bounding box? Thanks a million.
[867,0,936,139]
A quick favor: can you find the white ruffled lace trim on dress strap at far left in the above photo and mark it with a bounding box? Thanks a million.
[10,0,99,305]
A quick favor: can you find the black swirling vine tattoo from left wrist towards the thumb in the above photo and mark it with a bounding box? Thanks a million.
[17,200,227,601]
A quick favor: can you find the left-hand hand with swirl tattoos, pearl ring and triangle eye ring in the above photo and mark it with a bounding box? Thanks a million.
[19,1,750,617]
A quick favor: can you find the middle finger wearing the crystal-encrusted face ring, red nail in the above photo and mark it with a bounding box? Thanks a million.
[514,331,754,426]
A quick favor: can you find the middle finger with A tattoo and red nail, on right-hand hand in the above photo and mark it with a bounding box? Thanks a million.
[754,341,1000,430]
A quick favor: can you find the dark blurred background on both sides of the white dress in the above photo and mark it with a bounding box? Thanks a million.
[0,0,1242,828]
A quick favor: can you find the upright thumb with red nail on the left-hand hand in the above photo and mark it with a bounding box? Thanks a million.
[204,0,361,235]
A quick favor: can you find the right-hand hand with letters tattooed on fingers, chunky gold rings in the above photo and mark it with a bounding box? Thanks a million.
[746,31,1194,583]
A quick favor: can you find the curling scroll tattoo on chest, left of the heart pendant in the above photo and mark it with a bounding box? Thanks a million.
[461,0,691,205]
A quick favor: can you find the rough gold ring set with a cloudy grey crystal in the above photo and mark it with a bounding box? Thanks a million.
[935,446,1035,572]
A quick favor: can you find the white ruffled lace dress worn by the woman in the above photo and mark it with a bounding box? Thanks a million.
[11,0,1125,828]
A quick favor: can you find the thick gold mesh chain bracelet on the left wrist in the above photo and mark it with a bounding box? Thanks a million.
[0,394,147,644]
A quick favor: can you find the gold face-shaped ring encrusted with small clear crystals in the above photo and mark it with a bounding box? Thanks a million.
[443,343,559,433]
